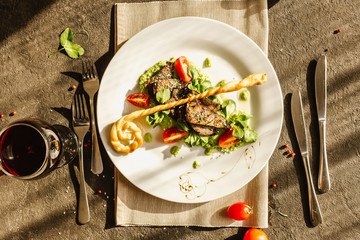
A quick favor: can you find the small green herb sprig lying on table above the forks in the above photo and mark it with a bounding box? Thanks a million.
[49,28,85,58]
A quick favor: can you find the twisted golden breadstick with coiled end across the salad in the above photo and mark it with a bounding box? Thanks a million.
[110,73,267,153]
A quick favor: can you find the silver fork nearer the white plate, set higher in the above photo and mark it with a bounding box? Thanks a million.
[82,59,103,174]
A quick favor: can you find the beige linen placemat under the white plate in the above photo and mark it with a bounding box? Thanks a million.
[114,0,268,228]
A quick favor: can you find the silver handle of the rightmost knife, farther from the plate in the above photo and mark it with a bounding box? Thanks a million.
[318,120,330,193]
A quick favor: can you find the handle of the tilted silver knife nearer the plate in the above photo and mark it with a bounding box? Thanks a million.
[302,155,323,227]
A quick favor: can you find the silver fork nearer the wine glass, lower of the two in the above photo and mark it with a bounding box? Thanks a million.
[71,94,90,224]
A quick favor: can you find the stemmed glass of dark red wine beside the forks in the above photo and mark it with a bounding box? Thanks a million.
[0,119,78,179]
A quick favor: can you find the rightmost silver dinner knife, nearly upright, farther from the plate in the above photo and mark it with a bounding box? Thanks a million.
[315,55,330,193]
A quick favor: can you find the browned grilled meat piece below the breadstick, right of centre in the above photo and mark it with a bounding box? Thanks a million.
[185,100,229,135]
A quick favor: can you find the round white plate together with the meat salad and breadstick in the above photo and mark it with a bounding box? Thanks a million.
[97,17,283,203]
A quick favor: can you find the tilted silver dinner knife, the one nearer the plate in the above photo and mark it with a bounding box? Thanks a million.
[291,91,322,226]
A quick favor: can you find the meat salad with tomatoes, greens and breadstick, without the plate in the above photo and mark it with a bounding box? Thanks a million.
[111,56,266,155]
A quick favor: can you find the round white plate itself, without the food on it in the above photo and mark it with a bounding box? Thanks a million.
[97,17,283,203]
